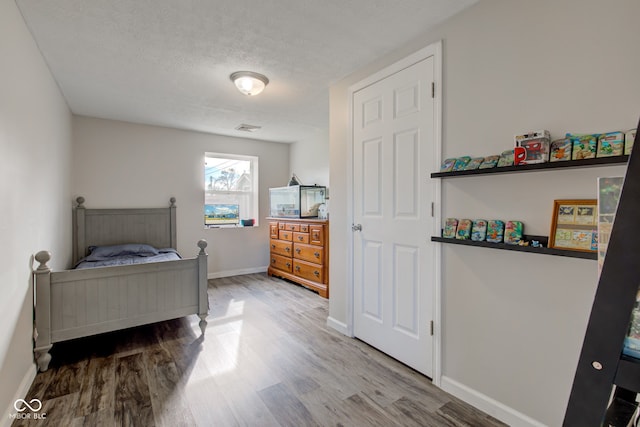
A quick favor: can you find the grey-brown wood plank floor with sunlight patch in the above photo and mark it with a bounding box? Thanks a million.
[13,274,504,427]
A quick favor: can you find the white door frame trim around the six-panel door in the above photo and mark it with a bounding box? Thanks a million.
[345,40,442,387]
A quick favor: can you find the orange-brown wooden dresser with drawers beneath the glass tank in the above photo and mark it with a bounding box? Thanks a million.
[267,218,329,298]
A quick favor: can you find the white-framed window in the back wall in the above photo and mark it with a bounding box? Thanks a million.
[204,153,258,228]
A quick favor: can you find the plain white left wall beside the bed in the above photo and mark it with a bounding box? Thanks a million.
[0,0,71,425]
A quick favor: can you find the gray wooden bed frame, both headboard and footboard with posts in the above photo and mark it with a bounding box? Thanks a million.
[33,197,209,372]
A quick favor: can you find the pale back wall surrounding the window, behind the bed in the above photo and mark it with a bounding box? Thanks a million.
[72,116,289,277]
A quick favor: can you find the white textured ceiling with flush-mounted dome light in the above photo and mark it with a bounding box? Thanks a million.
[16,0,477,142]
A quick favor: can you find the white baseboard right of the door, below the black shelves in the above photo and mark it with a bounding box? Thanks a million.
[440,375,546,427]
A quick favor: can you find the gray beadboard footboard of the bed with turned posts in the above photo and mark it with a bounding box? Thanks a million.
[33,240,209,371]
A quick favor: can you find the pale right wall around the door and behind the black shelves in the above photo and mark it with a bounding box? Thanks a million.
[330,0,640,426]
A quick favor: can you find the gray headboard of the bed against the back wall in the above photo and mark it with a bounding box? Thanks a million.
[73,197,177,263]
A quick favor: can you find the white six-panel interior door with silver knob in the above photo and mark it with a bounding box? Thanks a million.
[352,56,435,377]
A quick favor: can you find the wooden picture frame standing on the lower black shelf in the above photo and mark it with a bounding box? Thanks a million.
[549,199,598,252]
